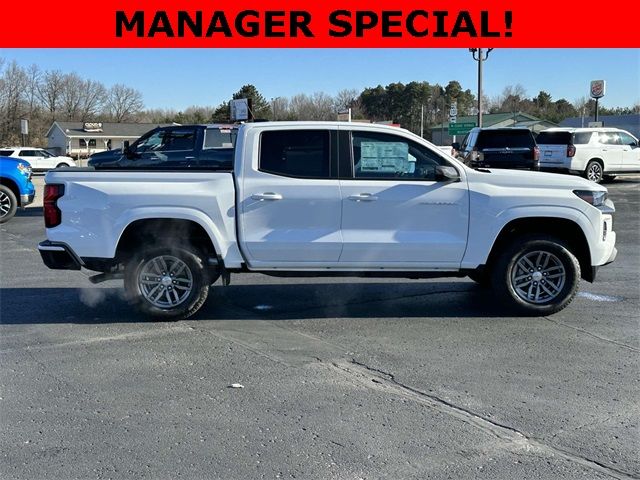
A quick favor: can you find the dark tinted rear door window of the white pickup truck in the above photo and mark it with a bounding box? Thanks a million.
[260,130,331,178]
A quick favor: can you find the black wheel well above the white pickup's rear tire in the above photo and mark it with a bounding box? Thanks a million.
[116,218,216,262]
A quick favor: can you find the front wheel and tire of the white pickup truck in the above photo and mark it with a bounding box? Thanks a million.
[491,235,580,316]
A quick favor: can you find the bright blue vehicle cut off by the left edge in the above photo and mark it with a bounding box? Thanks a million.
[0,157,36,223]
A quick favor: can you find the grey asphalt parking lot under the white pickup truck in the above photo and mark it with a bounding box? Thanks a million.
[0,177,640,479]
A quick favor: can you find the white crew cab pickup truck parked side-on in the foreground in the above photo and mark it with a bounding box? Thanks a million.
[39,122,616,319]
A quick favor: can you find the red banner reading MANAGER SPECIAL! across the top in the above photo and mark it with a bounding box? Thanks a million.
[0,0,640,48]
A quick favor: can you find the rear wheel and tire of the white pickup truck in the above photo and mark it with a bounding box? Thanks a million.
[124,246,211,321]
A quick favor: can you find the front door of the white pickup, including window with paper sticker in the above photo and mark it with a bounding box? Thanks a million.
[340,131,469,268]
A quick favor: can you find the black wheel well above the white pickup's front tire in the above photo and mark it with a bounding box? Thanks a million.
[487,217,592,280]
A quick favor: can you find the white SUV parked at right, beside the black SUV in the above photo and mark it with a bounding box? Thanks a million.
[536,128,640,183]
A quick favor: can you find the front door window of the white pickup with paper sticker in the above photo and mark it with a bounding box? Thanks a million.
[352,132,447,180]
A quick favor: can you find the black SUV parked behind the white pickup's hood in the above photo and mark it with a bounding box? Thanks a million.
[453,127,539,170]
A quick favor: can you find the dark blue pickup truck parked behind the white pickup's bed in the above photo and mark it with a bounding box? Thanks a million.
[88,124,238,169]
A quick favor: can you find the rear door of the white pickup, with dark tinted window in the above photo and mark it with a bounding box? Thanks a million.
[236,126,342,269]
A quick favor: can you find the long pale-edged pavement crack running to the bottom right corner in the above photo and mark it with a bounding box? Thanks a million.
[331,359,640,480]
